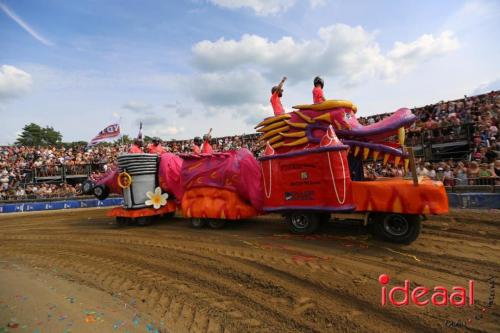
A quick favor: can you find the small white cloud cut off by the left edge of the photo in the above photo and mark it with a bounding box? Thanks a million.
[0,65,33,102]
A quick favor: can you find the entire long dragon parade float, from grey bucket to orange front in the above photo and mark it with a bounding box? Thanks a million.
[84,100,448,243]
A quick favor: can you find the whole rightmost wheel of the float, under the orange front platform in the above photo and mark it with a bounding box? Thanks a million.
[373,213,422,244]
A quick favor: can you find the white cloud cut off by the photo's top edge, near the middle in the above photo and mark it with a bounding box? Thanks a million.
[209,0,292,15]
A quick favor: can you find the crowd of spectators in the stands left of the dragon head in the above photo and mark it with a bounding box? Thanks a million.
[0,134,260,200]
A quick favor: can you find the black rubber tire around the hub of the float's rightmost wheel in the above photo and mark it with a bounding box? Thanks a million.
[371,213,422,244]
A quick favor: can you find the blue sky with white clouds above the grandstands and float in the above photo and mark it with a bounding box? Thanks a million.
[0,0,500,144]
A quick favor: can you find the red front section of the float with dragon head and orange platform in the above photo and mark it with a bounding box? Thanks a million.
[256,100,448,243]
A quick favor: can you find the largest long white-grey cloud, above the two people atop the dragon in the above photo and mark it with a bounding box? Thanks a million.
[192,24,458,85]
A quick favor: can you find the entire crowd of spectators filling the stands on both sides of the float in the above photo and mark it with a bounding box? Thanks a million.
[0,91,500,200]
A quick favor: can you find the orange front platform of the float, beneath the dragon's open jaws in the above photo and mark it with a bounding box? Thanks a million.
[352,178,448,215]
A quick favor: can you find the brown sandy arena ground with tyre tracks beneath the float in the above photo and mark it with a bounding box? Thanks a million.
[0,209,500,333]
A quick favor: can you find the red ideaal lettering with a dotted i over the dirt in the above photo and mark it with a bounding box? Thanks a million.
[378,274,474,307]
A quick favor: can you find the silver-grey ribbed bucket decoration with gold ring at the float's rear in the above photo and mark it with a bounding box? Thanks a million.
[118,154,159,208]
